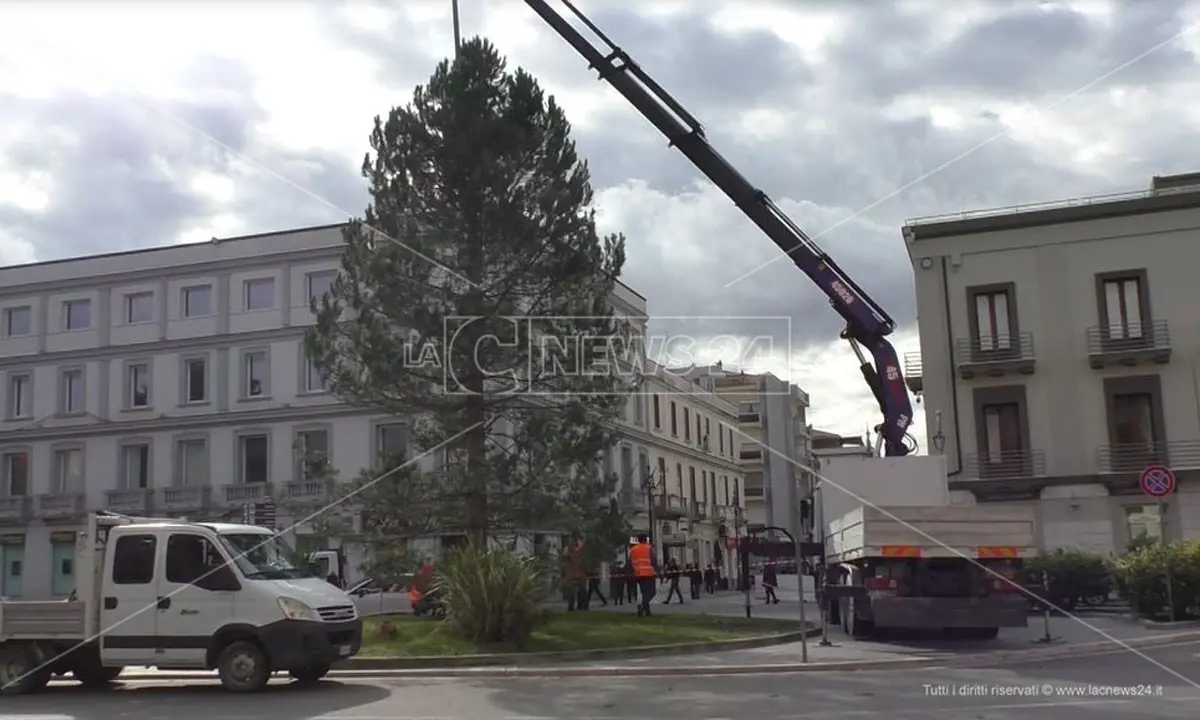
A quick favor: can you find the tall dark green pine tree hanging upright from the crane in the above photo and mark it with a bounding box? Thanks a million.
[305,38,637,568]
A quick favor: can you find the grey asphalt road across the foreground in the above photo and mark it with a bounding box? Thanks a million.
[16,643,1200,720]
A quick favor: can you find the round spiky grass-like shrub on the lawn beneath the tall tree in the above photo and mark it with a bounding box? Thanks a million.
[434,544,545,648]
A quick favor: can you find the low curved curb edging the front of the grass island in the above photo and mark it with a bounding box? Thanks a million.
[334,626,821,672]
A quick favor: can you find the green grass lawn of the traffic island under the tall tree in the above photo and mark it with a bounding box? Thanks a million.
[360,611,799,658]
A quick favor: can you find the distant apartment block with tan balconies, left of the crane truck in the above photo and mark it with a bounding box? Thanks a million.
[690,364,814,536]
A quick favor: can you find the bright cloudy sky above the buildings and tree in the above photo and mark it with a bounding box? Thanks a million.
[0,0,1200,438]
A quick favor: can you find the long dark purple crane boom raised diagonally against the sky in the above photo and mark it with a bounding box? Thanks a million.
[526,0,912,457]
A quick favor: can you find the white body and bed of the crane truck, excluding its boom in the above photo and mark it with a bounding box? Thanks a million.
[818,457,1037,640]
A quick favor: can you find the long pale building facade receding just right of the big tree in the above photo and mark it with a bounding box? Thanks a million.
[607,360,744,568]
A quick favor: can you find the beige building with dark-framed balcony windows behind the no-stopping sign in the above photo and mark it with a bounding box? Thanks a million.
[904,174,1200,552]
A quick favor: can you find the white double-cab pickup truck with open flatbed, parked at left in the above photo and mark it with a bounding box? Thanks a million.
[0,511,362,695]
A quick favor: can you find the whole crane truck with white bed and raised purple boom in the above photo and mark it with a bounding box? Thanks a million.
[526,0,1034,637]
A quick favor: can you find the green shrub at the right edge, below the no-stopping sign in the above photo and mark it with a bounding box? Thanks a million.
[1112,540,1200,618]
